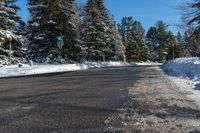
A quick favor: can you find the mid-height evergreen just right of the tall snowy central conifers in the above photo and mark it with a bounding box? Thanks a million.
[118,17,148,62]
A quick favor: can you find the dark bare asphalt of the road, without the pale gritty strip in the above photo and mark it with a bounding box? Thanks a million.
[0,67,138,133]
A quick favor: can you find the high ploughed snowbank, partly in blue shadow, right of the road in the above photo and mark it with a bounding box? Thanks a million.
[163,57,200,107]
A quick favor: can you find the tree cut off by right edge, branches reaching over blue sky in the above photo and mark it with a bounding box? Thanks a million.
[181,0,200,56]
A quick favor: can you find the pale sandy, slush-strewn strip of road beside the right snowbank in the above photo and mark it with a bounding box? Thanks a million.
[105,67,200,133]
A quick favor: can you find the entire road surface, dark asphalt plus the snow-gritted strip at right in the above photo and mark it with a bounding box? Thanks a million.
[0,66,200,133]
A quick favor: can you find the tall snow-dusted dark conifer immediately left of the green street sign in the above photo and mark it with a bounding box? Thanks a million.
[27,0,50,62]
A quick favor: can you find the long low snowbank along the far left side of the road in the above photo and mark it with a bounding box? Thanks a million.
[0,62,130,77]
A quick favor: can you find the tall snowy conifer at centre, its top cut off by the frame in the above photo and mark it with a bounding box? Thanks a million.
[83,0,113,61]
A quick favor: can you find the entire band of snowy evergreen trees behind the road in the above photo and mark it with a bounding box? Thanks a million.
[0,0,200,65]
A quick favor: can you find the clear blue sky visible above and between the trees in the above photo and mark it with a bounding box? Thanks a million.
[17,0,183,33]
